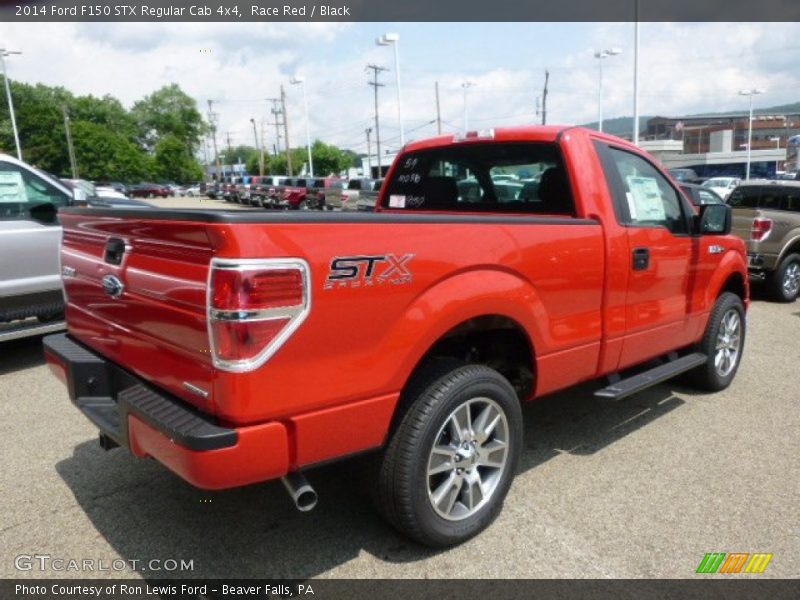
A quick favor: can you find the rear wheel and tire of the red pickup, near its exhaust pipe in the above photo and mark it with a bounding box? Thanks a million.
[376,361,523,547]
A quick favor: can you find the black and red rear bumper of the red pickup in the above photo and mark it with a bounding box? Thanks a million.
[44,334,289,489]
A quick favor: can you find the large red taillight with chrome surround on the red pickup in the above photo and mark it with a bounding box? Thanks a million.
[208,259,311,371]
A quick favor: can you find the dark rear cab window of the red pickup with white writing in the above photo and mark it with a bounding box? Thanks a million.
[383,143,574,215]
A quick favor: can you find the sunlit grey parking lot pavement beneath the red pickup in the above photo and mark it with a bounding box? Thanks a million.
[0,301,800,578]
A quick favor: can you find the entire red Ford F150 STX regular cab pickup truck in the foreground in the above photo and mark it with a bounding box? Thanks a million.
[45,127,749,546]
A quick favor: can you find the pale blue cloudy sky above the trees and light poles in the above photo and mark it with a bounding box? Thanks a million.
[0,23,800,157]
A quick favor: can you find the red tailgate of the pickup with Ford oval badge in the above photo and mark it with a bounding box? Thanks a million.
[61,212,215,412]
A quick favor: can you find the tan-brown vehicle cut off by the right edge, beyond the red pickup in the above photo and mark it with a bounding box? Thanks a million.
[728,180,800,302]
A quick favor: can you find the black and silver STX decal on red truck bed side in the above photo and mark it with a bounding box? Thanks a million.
[323,254,414,290]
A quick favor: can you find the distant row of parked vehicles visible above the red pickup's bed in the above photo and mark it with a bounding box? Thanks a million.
[208,175,383,211]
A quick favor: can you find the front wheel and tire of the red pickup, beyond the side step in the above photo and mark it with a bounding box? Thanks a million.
[689,292,746,392]
